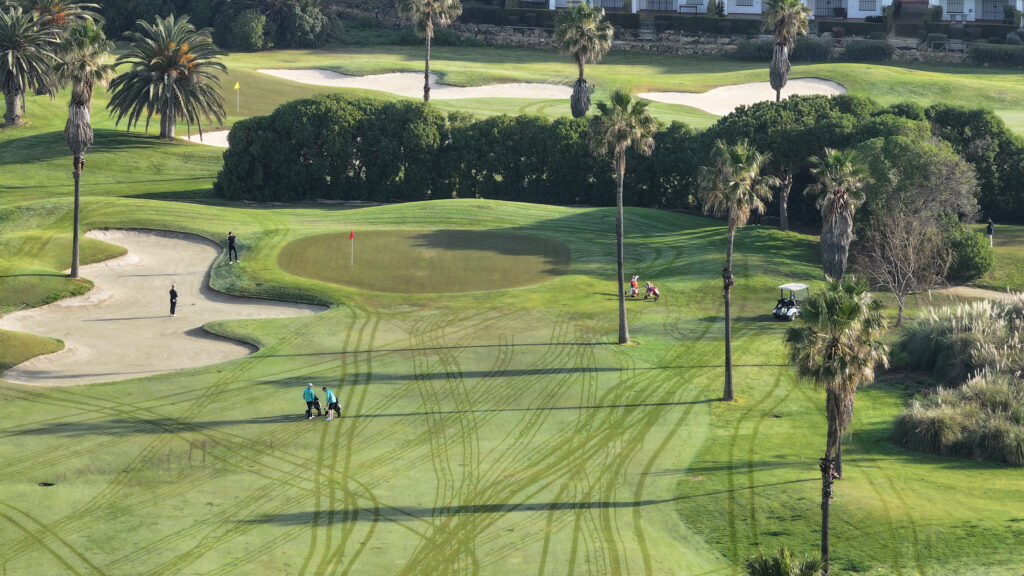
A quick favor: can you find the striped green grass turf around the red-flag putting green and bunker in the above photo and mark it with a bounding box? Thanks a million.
[0,43,1024,576]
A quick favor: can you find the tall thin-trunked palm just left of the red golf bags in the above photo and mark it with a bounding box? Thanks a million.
[590,89,657,344]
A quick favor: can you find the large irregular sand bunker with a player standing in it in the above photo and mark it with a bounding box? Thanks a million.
[0,231,325,385]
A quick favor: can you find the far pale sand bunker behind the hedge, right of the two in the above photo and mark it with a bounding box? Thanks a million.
[639,78,846,116]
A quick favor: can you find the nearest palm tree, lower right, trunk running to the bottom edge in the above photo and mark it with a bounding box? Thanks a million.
[785,279,889,574]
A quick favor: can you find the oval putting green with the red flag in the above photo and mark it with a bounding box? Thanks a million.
[278,230,571,294]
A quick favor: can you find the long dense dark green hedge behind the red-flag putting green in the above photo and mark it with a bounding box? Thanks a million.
[215,94,1024,223]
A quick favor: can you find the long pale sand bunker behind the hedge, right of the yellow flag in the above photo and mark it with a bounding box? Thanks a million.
[259,69,572,100]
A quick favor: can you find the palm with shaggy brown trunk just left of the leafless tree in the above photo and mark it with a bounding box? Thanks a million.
[804,148,870,280]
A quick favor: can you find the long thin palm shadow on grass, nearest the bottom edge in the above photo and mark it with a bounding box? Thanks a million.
[238,478,818,526]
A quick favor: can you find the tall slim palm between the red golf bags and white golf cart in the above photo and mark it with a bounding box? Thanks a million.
[699,139,779,402]
